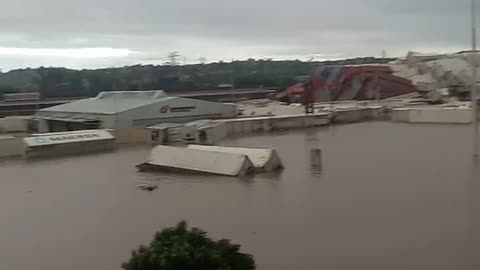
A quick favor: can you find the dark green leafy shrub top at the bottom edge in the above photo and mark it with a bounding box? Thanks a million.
[122,221,255,270]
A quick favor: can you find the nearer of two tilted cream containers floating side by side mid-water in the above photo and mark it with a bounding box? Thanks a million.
[137,145,255,177]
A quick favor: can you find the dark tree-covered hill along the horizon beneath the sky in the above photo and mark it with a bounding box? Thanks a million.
[0,57,394,98]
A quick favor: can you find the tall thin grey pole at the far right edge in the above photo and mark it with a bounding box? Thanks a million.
[471,0,478,158]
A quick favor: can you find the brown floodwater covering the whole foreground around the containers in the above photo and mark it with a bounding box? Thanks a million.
[0,123,480,270]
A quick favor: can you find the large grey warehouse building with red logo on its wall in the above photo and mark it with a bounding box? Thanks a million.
[35,90,237,132]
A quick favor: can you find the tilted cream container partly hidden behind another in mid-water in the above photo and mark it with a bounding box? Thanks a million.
[188,145,283,172]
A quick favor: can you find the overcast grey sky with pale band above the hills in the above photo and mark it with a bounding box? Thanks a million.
[0,0,470,71]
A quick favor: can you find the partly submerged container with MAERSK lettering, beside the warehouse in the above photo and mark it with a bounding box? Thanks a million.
[23,129,115,158]
